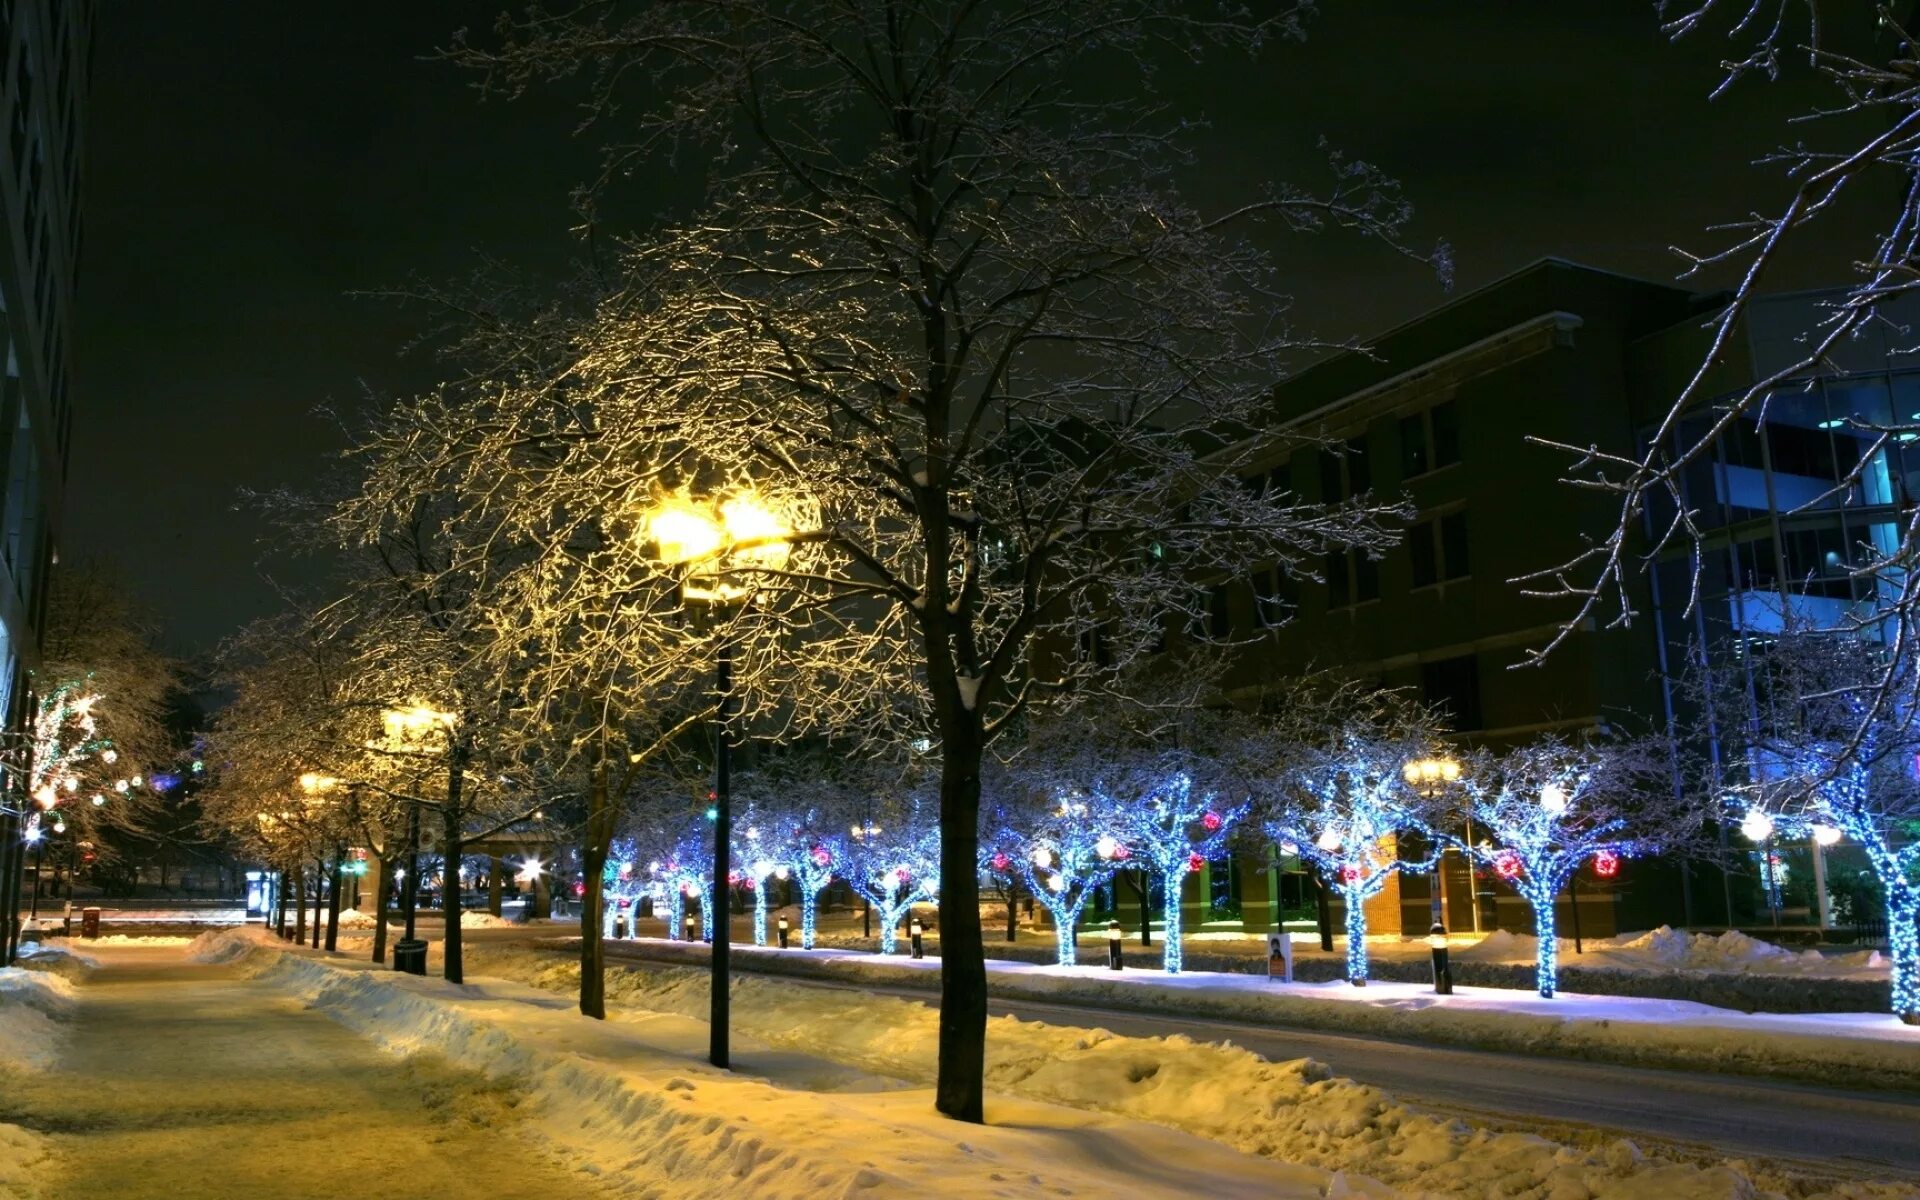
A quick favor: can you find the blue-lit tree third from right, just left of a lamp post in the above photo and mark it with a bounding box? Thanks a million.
[1265,724,1434,987]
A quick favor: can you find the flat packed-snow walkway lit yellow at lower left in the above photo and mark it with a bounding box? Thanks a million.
[0,947,599,1200]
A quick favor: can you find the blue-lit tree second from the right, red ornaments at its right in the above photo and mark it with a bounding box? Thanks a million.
[1452,737,1699,998]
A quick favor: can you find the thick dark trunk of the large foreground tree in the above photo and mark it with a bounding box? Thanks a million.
[933,712,987,1123]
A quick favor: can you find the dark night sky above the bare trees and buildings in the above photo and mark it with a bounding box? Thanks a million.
[61,0,1864,651]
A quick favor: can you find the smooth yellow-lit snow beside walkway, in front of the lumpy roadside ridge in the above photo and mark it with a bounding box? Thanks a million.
[198,935,1344,1200]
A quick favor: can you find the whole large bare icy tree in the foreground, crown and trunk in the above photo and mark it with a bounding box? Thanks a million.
[453,0,1443,1121]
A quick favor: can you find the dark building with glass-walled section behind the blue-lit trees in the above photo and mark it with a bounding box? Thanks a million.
[1208,259,1920,935]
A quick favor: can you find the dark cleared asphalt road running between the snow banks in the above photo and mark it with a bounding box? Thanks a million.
[579,947,1920,1181]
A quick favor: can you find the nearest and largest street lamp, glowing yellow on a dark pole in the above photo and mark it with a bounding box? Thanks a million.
[639,492,793,1069]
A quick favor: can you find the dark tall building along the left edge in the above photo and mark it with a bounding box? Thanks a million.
[0,0,94,720]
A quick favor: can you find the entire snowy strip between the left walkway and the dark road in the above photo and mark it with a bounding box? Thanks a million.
[139,933,1920,1200]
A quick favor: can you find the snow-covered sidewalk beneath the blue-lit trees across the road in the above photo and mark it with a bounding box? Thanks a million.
[609,939,1920,1089]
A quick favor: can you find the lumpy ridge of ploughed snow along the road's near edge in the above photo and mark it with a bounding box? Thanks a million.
[470,947,1908,1200]
